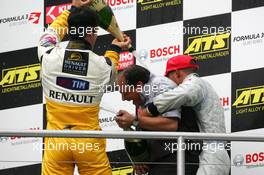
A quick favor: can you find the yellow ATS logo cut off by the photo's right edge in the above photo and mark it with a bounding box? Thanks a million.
[232,85,264,114]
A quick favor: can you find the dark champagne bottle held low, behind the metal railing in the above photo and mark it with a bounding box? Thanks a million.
[124,128,150,163]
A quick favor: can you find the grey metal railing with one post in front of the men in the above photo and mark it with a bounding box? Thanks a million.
[0,130,264,175]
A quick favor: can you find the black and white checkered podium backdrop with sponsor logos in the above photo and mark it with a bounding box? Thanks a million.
[0,0,264,175]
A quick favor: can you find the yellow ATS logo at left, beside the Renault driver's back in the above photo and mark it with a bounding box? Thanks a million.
[0,64,41,93]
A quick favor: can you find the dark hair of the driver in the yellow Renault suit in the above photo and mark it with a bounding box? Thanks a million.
[68,7,99,40]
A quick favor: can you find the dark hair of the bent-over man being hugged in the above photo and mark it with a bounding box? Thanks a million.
[122,65,150,86]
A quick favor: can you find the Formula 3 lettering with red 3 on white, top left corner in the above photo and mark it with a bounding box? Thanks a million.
[0,12,41,26]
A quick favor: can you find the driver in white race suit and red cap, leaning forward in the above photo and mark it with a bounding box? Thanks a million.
[139,55,230,175]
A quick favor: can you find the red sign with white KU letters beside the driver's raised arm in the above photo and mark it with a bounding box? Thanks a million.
[46,3,71,24]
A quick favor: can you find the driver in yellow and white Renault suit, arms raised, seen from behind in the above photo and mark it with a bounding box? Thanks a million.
[38,0,131,175]
